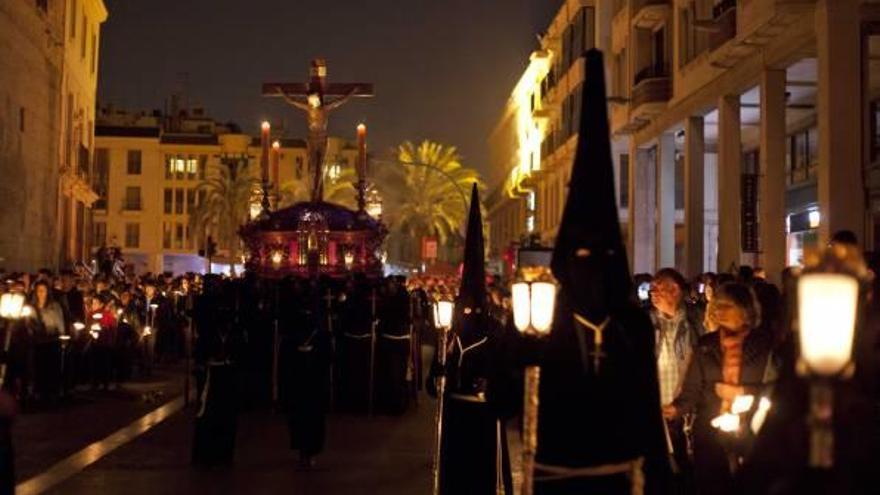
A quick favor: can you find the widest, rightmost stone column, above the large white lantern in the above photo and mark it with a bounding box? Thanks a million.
[815,0,865,245]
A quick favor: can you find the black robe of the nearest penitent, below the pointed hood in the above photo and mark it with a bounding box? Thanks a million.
[535,298,667,495]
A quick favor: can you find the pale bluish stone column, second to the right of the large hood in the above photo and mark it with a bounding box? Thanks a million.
[656,132,675,268]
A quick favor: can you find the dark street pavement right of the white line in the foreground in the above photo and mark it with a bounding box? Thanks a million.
[39,399,434,495]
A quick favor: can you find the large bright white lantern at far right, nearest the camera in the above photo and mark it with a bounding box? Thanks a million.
[797,244,867,469]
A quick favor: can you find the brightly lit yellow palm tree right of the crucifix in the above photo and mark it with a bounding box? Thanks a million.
[376,140,485,264]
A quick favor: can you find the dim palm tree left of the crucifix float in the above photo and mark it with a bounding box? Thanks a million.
[190,164,259,262]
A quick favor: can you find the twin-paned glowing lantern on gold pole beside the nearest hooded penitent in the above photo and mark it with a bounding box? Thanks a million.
[511,267,556,495]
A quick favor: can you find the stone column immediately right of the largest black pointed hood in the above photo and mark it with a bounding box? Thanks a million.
[627,142,656,273]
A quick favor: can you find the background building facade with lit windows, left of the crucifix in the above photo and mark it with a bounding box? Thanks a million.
[92,108,357,274]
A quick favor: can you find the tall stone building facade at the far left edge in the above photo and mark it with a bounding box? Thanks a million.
[0,0,107,270]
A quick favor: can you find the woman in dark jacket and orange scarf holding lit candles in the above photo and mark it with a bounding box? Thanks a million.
[663,283,777,495]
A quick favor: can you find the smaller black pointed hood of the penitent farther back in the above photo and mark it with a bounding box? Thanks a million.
[456,183,486,308]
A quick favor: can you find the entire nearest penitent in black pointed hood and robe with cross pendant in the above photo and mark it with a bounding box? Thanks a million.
[535,50,668,495]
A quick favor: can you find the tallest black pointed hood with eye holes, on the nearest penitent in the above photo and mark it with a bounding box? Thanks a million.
[551,49,632,316]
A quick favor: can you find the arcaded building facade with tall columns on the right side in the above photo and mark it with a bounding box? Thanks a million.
[493,0,880,281]
